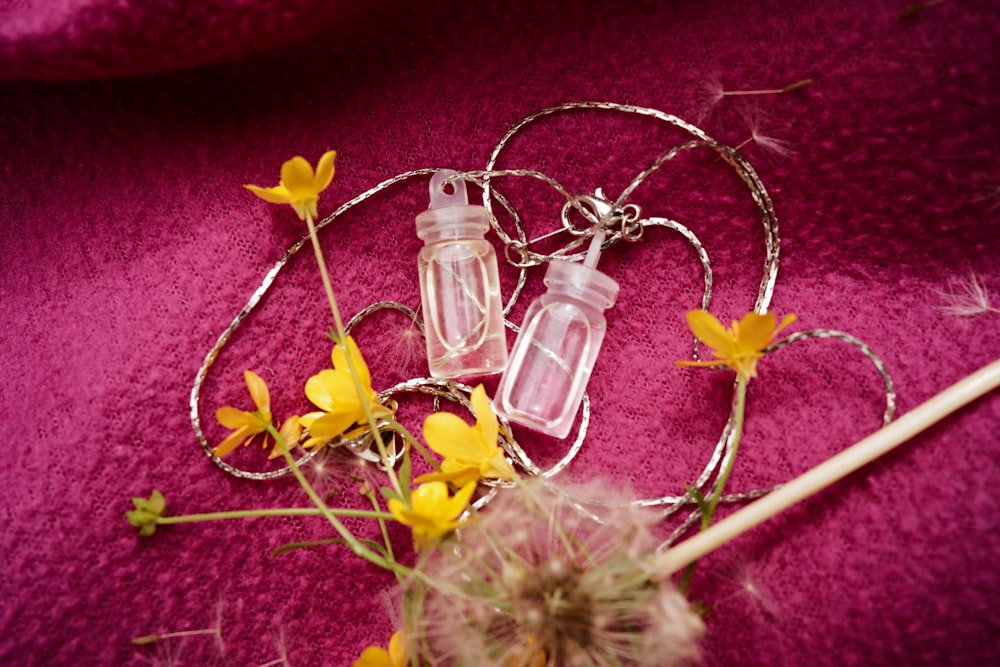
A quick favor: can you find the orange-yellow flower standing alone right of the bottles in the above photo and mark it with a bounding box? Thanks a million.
[677,310,797,379]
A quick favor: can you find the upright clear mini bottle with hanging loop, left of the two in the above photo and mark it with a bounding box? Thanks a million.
[417,169,507,378]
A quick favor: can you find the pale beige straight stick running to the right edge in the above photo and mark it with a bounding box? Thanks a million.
[655,359,1000,577]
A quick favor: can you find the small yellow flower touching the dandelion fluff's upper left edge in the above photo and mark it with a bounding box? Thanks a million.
[389,482,476,551]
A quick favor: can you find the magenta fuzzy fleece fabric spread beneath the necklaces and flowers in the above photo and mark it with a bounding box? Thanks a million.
[0,0,1000,666]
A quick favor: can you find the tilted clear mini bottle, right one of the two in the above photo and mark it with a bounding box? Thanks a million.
[493,256,618,438]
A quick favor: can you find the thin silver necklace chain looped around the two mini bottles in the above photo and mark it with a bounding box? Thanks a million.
[190,102,895,548]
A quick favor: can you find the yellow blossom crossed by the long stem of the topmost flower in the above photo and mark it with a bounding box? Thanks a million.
[299,336,392,448]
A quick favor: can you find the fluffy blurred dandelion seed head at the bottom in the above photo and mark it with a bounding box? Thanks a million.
[410,480,703,667]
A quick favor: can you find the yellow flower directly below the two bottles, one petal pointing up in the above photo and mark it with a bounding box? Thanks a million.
[416,385,515,486]
